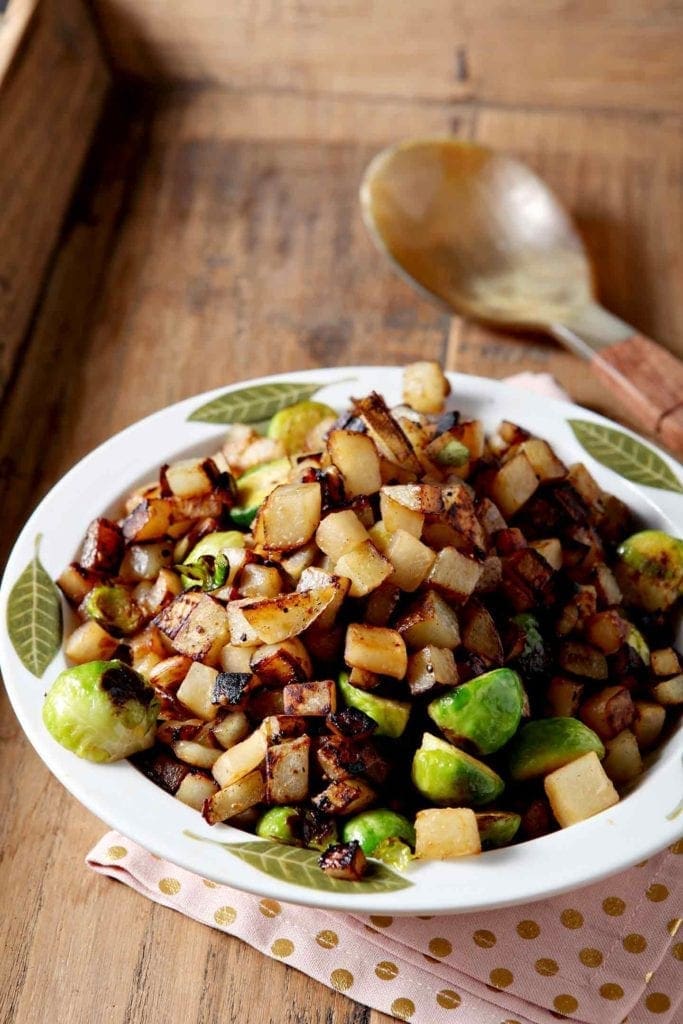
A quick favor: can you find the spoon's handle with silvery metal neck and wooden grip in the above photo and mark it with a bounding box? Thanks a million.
[551,302,683,459]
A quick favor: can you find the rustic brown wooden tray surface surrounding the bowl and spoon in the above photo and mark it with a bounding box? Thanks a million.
[0,0,683,1024]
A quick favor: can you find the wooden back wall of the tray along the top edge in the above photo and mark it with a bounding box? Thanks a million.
[90,0,683,113]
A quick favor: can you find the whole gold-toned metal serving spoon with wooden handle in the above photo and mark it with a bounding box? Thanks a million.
[360,138,683,456]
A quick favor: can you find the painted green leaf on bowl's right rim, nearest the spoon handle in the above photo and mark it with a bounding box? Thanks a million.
[568,420,683,495]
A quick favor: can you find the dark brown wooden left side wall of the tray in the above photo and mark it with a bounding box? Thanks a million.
[0,0,109,394]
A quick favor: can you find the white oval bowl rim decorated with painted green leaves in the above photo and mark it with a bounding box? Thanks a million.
[0,367,683,914]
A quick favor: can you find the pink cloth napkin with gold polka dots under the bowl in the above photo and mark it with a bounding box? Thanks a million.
[92,833,683,1024]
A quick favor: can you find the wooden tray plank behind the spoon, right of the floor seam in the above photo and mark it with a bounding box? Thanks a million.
[450,110,683,436]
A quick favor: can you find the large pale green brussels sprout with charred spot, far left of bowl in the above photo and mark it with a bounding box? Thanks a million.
[43,660,160,762]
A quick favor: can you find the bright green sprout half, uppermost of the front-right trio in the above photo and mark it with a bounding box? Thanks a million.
[427,669,524,754]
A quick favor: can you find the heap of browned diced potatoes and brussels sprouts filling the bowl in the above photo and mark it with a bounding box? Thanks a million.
[43,362,683,880]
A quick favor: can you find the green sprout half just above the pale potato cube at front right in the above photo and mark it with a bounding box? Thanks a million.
[509,718,605,782]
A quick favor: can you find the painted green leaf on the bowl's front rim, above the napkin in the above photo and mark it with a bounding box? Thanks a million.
[185,831,413,896]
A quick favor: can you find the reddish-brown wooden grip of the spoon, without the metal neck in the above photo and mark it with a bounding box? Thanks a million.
[591,334,683,458]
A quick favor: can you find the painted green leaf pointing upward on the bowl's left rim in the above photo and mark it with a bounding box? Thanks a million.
[7,536,61,679]
